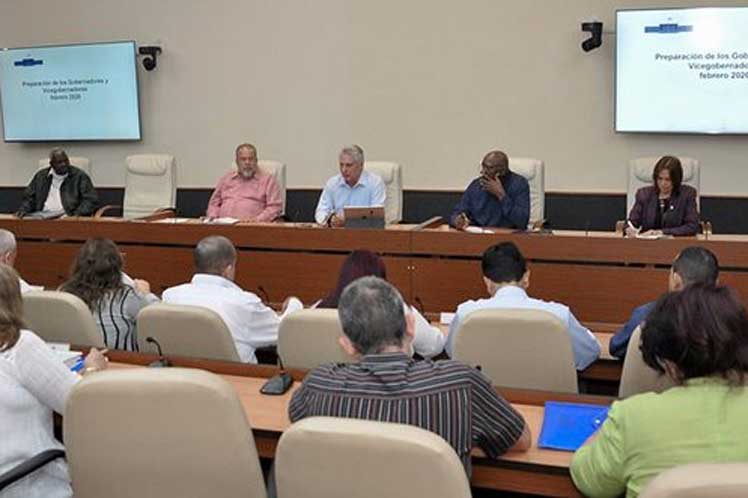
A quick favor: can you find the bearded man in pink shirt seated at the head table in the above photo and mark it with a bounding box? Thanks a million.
[206,144,283,222]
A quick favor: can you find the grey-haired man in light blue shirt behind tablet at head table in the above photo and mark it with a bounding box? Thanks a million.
[314,145,386,227]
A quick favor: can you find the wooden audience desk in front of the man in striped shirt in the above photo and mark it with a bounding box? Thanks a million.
[108,351,613,497]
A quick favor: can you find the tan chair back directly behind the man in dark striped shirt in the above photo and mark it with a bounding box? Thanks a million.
[275,417,470,498]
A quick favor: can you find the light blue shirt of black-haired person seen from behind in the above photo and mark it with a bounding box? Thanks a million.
[447,285,600,370]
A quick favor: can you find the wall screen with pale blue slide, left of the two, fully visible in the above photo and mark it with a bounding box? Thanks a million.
[0,42,140,142]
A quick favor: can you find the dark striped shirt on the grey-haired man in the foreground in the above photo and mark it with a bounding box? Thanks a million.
[288,353,525,475]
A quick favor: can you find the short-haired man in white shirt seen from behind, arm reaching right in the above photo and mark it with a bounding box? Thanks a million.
[162,235,304,363]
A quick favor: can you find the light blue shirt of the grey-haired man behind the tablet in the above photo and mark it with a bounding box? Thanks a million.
[314,170,386,225]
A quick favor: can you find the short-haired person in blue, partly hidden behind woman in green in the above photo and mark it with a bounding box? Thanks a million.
[610,246,719,359]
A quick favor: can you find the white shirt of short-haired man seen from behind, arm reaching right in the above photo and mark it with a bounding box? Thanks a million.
[161,273,304,363]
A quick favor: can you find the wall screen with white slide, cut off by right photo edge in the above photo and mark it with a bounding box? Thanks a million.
[616,7,748,134]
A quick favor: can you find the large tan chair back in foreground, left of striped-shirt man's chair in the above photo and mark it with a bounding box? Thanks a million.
[64,368,266,498]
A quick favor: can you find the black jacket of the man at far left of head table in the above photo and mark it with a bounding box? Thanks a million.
[18,166,99,216]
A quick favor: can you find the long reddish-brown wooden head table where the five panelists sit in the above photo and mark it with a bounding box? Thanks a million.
[0,215,748,323]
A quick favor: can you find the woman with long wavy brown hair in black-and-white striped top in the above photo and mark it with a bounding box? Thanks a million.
[60,239,159,351]
